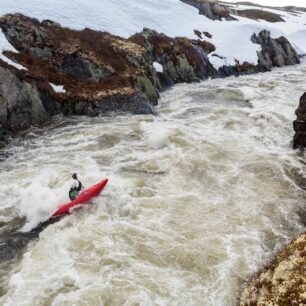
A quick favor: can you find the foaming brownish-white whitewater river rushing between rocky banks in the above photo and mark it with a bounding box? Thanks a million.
[0,62,306,306]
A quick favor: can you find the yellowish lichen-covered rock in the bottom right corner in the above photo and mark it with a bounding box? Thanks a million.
[239,234,306,306]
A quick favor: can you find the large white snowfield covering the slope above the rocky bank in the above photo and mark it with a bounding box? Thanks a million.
[0,0,306,68]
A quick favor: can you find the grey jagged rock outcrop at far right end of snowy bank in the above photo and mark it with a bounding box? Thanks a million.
[251,30,300,71]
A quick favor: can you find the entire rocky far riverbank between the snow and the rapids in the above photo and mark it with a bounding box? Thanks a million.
[0,14,299,145]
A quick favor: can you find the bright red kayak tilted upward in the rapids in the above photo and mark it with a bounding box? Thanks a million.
[52,179,108,217]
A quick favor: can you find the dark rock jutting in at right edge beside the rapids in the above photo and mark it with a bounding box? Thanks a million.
[293,93,306,149]
